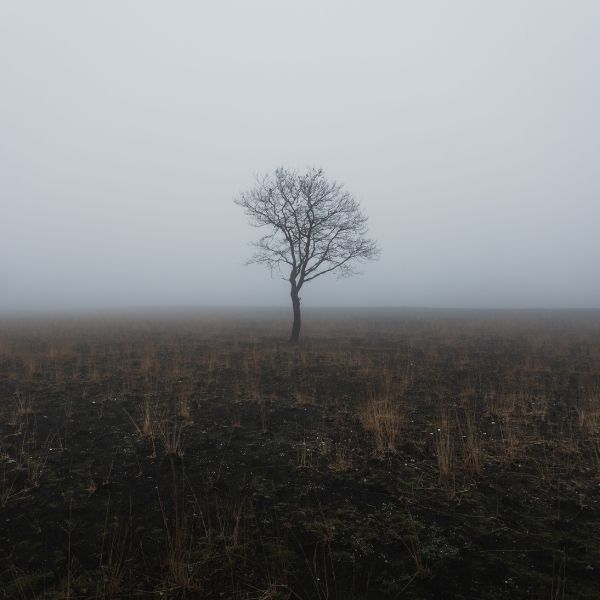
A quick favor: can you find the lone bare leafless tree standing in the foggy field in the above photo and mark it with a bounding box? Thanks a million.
[235,168,379,343]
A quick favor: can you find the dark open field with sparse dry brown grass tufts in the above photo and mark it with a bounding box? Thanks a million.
[0,310,600,600]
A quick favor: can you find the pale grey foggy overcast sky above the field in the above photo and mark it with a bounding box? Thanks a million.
[0,0,600,310]
